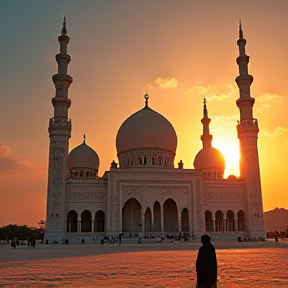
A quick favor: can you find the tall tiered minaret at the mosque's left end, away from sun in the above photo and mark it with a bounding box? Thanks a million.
[44,17,73,243]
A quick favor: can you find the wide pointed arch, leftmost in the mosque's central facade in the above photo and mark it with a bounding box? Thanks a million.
[122,198,142,234]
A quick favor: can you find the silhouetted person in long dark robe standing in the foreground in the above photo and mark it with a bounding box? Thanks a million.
[196,235,217,288]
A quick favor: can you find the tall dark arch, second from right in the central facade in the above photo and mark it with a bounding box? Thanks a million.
[163,198,178,233]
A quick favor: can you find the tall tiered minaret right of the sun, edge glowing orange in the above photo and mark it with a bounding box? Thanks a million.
[235,20,266,238]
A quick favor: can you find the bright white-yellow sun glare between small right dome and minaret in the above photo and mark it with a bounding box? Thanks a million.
[213,136,240,178]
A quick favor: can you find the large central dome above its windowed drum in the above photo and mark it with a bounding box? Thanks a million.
[116,106,177,154]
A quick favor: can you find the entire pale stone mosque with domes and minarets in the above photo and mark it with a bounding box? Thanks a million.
[44,18,266,243]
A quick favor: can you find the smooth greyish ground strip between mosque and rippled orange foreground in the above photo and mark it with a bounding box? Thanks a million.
[0,239,288,263]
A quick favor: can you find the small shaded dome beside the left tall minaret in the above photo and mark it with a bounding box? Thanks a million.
[67,140,99,170]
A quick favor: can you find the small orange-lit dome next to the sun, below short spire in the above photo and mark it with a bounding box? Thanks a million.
[194,146,225,170]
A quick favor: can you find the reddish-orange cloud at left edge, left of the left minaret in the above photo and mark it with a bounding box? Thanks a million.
[0,145,41,174]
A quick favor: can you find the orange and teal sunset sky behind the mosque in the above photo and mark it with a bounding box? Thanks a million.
[0,0,288,227]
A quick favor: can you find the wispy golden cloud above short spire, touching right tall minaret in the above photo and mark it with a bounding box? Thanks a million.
[184,84,236,101]
